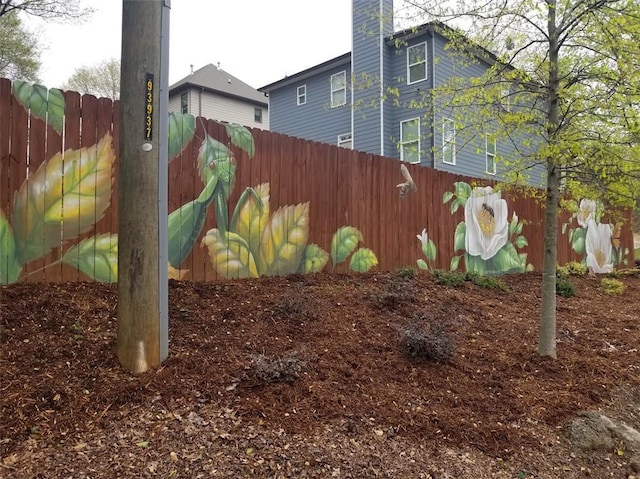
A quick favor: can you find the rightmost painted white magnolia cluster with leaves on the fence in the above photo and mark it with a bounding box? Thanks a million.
[562,198,630,273]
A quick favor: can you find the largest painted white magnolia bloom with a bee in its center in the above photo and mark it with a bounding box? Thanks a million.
[464,186,509,260]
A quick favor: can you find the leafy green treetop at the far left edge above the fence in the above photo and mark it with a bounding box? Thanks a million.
[0,12,40,82]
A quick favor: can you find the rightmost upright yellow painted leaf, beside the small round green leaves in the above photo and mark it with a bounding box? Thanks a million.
[258,202,309,276]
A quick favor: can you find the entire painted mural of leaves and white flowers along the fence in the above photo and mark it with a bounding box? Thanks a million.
[0,82,629,284]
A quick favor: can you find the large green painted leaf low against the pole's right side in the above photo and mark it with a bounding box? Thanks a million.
[167,200,207,268]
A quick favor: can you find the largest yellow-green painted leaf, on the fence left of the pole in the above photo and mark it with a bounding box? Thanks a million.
[12,133,115,263]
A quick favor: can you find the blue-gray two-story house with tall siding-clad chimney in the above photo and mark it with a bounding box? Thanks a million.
[259,0,528,179]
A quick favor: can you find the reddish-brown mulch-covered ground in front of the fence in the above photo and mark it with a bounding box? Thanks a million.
[0,273,640,479]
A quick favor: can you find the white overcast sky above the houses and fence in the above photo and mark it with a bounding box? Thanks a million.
[25,0,358,88]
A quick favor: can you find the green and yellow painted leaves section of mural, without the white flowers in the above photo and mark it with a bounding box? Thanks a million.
[0,82,378,284]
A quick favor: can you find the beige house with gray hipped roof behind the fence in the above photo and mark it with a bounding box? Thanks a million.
[169,64,269,130]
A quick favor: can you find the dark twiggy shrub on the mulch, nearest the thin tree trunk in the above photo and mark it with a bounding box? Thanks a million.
[401,323,456,362]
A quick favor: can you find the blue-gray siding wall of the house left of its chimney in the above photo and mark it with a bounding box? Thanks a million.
[269,63,351,145]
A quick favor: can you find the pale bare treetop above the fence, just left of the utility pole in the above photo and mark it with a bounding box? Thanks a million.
[64,58,120,100]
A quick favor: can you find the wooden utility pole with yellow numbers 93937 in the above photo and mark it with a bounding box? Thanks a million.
[117,0,170,373]
